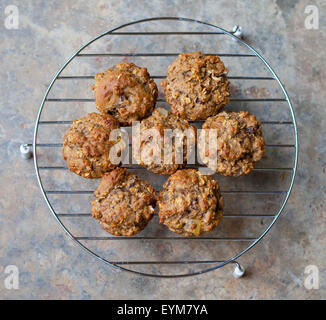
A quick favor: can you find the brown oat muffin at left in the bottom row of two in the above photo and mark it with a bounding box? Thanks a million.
[91,168,156,236]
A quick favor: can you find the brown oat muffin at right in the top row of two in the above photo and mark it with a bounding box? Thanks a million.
[161,52,230,120]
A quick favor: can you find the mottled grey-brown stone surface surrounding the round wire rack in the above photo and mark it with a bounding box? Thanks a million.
[0,0,326,299]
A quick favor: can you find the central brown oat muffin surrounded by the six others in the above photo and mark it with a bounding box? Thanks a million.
[132,108,196,174]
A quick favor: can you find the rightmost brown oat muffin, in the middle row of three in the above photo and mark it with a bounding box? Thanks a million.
[199,111,265,176]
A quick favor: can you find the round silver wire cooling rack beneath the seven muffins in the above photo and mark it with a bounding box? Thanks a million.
[33,17,298,277]
